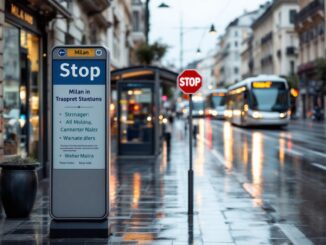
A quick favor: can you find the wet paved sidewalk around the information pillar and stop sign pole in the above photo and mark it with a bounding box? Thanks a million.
[0,121,291,245]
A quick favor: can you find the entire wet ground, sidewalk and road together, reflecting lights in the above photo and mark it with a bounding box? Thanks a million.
[0,119,326,245]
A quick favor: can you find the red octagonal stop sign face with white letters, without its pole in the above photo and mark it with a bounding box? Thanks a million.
[178,70,203,94]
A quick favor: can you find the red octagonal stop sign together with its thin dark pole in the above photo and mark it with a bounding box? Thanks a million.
[177,70,203,215]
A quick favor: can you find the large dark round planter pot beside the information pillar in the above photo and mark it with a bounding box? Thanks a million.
[0,162,38,218]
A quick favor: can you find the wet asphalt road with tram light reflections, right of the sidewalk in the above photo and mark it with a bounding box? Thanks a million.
[197,119,326,244]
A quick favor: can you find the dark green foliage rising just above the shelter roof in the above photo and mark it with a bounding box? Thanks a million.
[136,42,168,65]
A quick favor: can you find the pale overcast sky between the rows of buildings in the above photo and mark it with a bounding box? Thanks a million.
[149,0,266,68]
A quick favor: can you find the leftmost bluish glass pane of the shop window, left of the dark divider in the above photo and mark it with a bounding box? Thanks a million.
[3,24,23,155]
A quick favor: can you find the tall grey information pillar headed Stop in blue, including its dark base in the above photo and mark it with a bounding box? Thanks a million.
[50,46,110,237]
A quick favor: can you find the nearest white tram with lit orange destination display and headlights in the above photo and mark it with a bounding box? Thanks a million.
[226,75,290,126]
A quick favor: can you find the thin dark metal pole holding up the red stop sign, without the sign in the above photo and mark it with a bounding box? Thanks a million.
[188,94,194,215]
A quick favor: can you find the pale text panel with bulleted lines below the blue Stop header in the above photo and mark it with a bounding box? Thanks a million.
[53,85,105,169]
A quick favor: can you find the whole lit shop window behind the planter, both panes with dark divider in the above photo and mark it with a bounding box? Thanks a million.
[3,24,40,159]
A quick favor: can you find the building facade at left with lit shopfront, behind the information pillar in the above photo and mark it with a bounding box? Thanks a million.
[0,0,139,176]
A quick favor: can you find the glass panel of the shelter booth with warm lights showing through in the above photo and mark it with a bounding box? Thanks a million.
[120,87,153,143]
